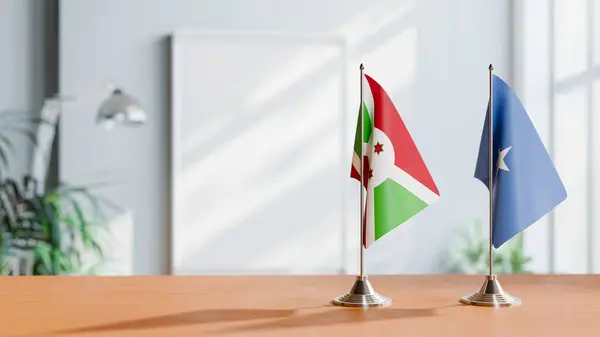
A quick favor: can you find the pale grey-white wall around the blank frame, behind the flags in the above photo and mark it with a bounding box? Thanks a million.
[60,0,512,274]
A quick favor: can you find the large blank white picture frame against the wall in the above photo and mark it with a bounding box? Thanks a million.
[169,30,356,275]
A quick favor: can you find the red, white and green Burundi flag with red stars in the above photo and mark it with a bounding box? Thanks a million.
[350,75,439,247]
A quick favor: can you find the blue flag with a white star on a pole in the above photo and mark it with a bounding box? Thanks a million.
[475,75,567,248]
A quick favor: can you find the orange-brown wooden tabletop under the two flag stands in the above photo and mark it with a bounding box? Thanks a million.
[0,275,600,337]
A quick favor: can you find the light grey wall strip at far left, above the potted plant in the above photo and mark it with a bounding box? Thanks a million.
[0,0,53,177]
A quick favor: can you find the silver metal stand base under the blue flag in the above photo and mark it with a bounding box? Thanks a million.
[460,275,521,308]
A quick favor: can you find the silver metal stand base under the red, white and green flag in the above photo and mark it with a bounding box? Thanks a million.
[331,275,392,308]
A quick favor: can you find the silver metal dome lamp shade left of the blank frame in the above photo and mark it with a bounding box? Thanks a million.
[97,89,146,128]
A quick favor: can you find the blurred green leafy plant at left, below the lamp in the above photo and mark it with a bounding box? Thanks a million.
[0,109,118,275]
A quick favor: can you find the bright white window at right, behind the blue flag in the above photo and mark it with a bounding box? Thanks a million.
[514,0,600,273]
